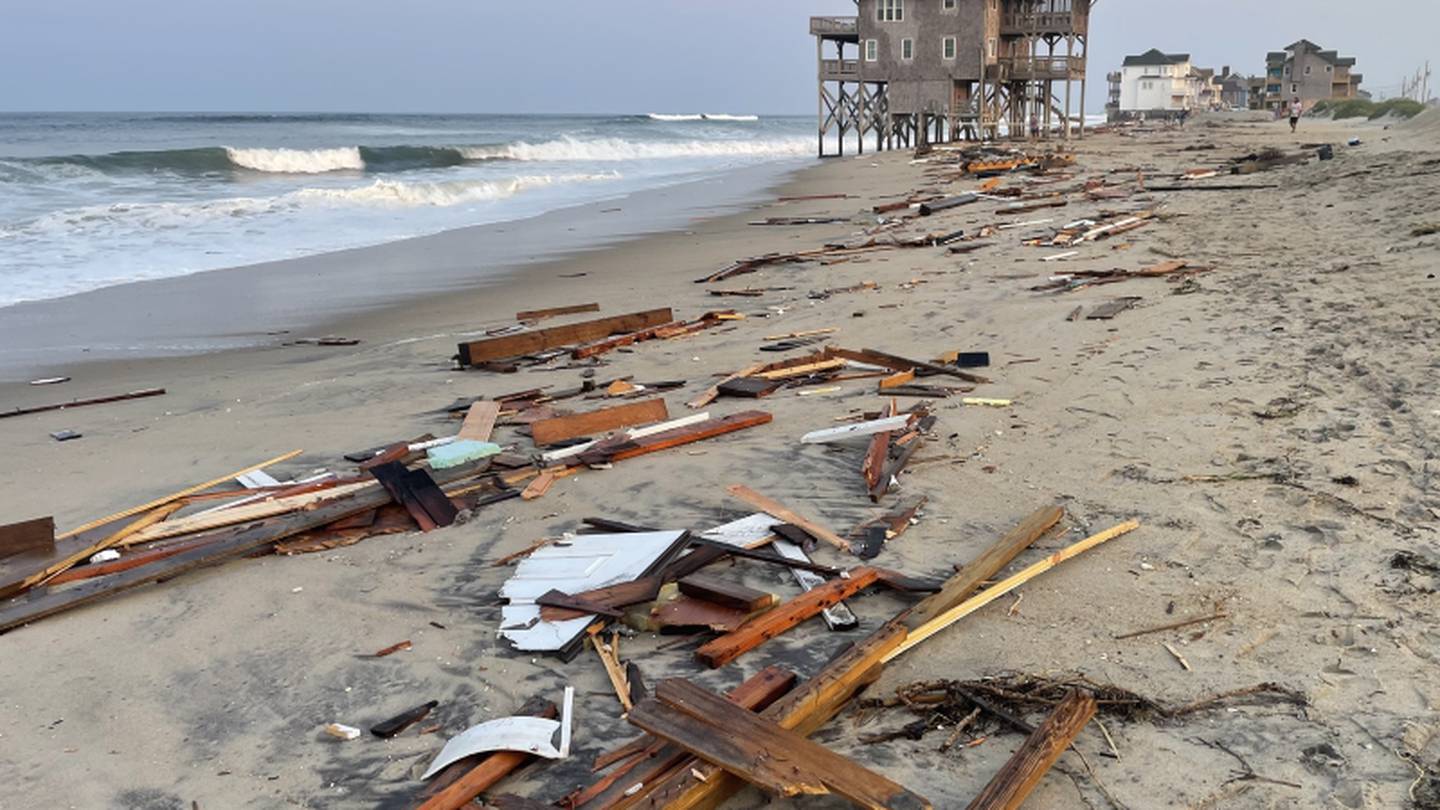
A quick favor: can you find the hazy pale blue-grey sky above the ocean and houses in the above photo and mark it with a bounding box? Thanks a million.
[0,0,1440,114]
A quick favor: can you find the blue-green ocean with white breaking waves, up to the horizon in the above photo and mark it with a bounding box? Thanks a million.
[0,114,815,307]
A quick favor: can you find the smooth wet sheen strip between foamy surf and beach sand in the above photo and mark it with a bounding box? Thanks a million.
[0,160,814,383]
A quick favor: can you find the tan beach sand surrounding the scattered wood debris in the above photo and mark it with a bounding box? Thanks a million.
[0,108,1440,810]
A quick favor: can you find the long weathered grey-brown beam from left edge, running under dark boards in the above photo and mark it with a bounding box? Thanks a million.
[0,464,484,633]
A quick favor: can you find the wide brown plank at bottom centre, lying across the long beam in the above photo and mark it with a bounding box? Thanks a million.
[629,679,932,810]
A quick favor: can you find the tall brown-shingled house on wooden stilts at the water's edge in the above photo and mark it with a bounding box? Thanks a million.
[811,0,1092,156]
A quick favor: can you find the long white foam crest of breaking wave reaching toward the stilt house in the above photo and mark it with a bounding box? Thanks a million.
[461,137,814,161]
